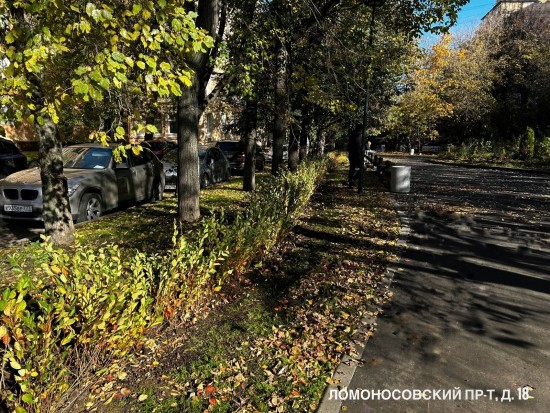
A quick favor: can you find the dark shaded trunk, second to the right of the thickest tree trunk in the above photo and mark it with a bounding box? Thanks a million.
[271,42,289,175]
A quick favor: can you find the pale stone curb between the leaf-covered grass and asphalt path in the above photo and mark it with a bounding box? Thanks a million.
[316,194,411,413]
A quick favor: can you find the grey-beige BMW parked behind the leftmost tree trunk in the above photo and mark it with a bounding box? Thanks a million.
[0,143,164,222]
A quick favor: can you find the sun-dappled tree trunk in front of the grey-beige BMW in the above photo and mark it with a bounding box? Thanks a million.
[36,118,74,245]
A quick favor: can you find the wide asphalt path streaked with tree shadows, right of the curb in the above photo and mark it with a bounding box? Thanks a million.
[340,157,550,413]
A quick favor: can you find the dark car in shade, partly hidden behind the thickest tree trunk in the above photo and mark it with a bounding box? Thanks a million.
[162,146,231,190]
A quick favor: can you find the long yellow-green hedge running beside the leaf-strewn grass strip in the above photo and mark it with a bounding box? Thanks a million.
[0,156,328,412]
